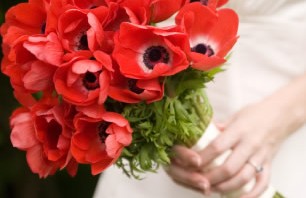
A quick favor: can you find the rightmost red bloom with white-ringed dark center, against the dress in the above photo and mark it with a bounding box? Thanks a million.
[176,3,238,70]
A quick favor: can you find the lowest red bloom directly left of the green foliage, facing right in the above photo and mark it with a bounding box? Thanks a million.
[71,107,132,175]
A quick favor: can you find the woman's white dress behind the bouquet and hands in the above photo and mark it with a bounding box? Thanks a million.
[94,0,306,198]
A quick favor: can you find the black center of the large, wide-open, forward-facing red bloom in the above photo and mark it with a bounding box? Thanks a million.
[143,46,170,69]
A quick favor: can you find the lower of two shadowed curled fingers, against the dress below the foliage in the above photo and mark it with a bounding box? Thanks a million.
[166,164,210,194]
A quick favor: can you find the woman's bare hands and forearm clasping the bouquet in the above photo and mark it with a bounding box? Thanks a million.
[167,74,306,198]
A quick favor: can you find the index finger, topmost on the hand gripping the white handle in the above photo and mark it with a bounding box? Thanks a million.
[199,127,238,167]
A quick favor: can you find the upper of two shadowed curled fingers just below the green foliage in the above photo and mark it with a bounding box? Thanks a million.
[172,146,201,168]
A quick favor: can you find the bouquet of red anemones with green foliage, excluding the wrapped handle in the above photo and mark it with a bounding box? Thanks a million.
[1,0,238,177]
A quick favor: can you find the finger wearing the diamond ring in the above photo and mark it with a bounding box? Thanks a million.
[214,149,267,193]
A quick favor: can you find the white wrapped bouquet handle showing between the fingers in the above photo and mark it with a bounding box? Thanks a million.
[192,122,277,198]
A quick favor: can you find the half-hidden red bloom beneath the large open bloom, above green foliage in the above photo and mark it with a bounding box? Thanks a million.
[109,63,164,103]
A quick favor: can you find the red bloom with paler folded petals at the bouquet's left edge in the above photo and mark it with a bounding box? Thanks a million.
[2,35,58,93]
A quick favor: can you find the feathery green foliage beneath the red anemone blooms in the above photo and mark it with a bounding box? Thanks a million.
[117,69,212,178]
